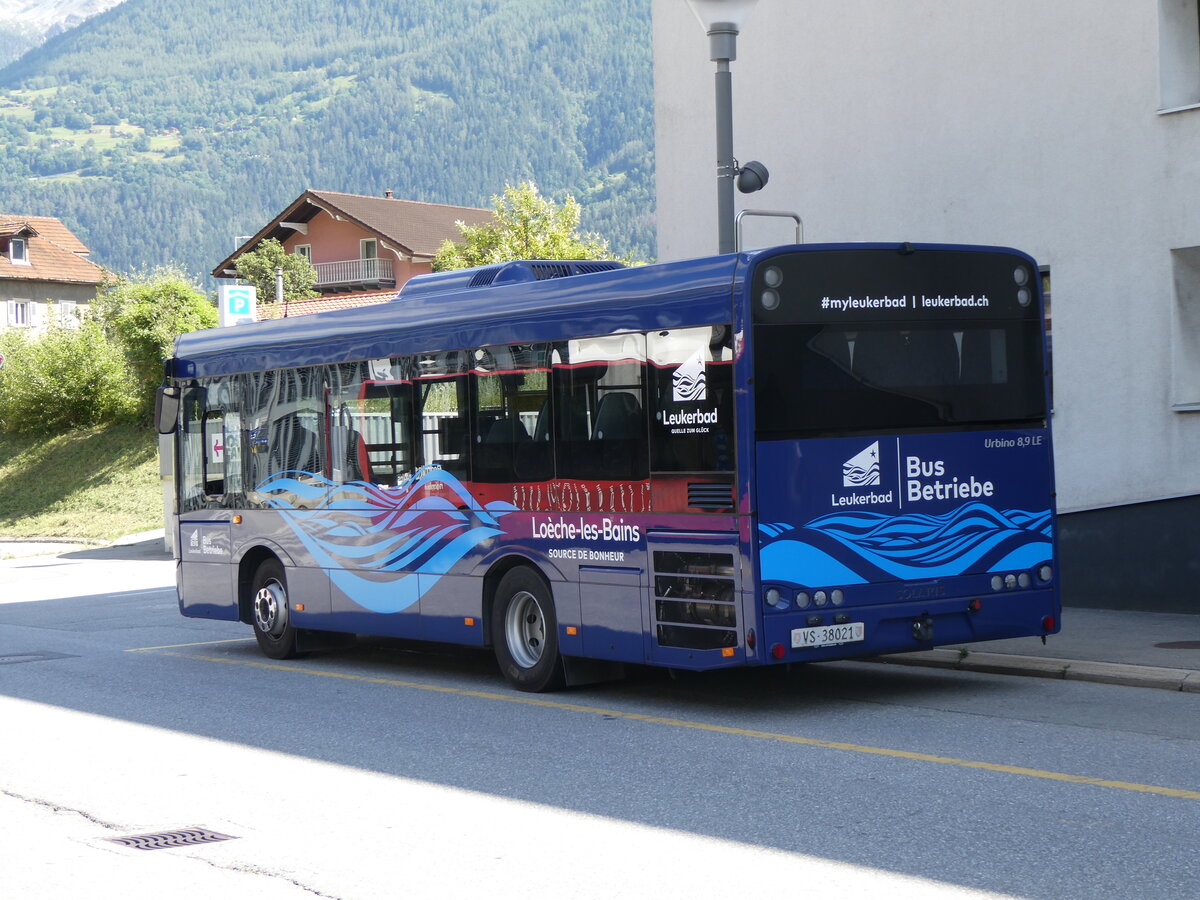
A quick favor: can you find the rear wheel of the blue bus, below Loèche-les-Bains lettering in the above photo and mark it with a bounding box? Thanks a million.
[491,566,565,692]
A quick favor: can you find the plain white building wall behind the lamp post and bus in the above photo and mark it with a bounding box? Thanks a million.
[654,0,1200,512]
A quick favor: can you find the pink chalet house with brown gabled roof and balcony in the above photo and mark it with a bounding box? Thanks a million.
[212,190,492,318]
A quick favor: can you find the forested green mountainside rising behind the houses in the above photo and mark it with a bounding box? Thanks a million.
[0,0,654,282]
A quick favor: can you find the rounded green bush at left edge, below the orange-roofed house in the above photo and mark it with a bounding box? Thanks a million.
[0,323,138,434]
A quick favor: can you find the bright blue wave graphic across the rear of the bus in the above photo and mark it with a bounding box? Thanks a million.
[758,503,1052,587]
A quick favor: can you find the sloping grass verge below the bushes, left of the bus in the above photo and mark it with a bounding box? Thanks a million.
[0,426,162,541]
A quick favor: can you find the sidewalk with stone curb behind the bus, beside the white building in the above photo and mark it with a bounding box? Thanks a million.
[876,607,1200,694]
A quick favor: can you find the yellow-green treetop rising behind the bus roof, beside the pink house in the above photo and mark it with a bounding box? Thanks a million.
[433,181,616,272]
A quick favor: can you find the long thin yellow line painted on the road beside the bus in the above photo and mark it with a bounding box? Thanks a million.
[154,657,1200,800]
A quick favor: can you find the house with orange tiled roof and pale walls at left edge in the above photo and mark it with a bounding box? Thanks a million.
[0,212,104,330]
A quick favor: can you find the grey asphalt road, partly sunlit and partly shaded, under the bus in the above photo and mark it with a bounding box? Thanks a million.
[0,551,1200,900]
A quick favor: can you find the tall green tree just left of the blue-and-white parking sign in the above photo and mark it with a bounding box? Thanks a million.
[90,262,217,415]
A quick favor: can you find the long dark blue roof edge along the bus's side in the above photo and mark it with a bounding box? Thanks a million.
[170,256,738,378]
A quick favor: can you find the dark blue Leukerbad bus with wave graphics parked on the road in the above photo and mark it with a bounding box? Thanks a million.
[158,244,1060,691]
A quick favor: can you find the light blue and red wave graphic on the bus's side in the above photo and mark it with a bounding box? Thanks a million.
[256,466,516,612]
